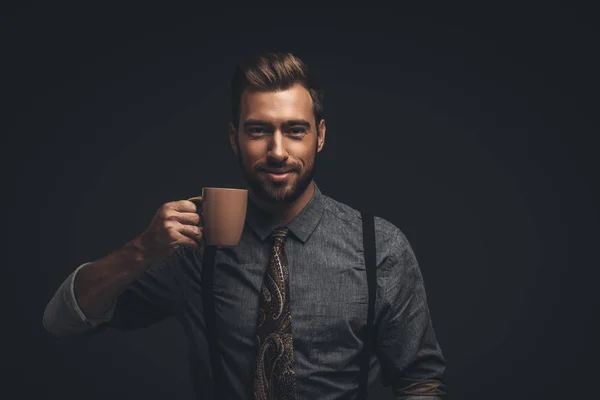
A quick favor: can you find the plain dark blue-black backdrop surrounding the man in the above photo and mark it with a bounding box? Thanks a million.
[0,2,599,400]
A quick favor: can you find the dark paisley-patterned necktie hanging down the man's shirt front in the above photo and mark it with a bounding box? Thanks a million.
[254,228,297,400]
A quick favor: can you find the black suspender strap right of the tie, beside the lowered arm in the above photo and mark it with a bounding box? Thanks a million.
[358,212,377,399]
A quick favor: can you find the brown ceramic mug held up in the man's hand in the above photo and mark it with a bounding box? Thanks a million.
[189,187,248,246]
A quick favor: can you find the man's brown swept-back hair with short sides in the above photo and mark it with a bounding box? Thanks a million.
[231,52,324,129]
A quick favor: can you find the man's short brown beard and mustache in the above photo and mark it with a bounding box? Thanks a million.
[238,144,317,204]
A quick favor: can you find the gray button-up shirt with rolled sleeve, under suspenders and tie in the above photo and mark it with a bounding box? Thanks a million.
[44,184,445,400]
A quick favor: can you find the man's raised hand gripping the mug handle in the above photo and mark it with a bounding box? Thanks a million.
[134,197,203,263]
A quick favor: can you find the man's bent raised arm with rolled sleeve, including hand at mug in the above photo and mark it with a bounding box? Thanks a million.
[43,200,202,336]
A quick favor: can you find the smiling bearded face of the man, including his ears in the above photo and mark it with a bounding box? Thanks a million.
[230,85,325,204]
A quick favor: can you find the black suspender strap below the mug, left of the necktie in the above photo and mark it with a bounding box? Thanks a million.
[202,246,226,399]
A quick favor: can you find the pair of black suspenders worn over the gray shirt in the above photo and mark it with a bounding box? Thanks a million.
[202,212,377,399]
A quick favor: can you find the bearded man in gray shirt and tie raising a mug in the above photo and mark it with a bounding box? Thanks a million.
[44,53,445,400]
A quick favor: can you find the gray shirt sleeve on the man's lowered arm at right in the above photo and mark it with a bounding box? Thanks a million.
[376,228,445,400]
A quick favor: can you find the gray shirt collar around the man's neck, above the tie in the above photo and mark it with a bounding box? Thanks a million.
[246,183,324,243]
